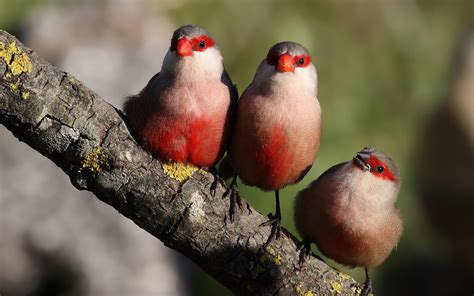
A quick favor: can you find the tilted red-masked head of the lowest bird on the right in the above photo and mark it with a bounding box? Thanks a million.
[352,147,400,183]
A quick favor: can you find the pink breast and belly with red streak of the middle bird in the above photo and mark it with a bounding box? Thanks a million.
[230,80,321,190]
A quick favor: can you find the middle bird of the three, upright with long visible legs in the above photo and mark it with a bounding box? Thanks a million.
[226,41,321,246]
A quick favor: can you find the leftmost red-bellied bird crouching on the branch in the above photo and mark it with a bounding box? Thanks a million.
[124,25,238,182]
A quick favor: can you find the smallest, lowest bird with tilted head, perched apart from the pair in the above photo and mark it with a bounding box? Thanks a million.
[294,147,403,295]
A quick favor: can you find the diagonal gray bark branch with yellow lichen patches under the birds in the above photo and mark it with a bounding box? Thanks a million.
[0,31,361,296]
